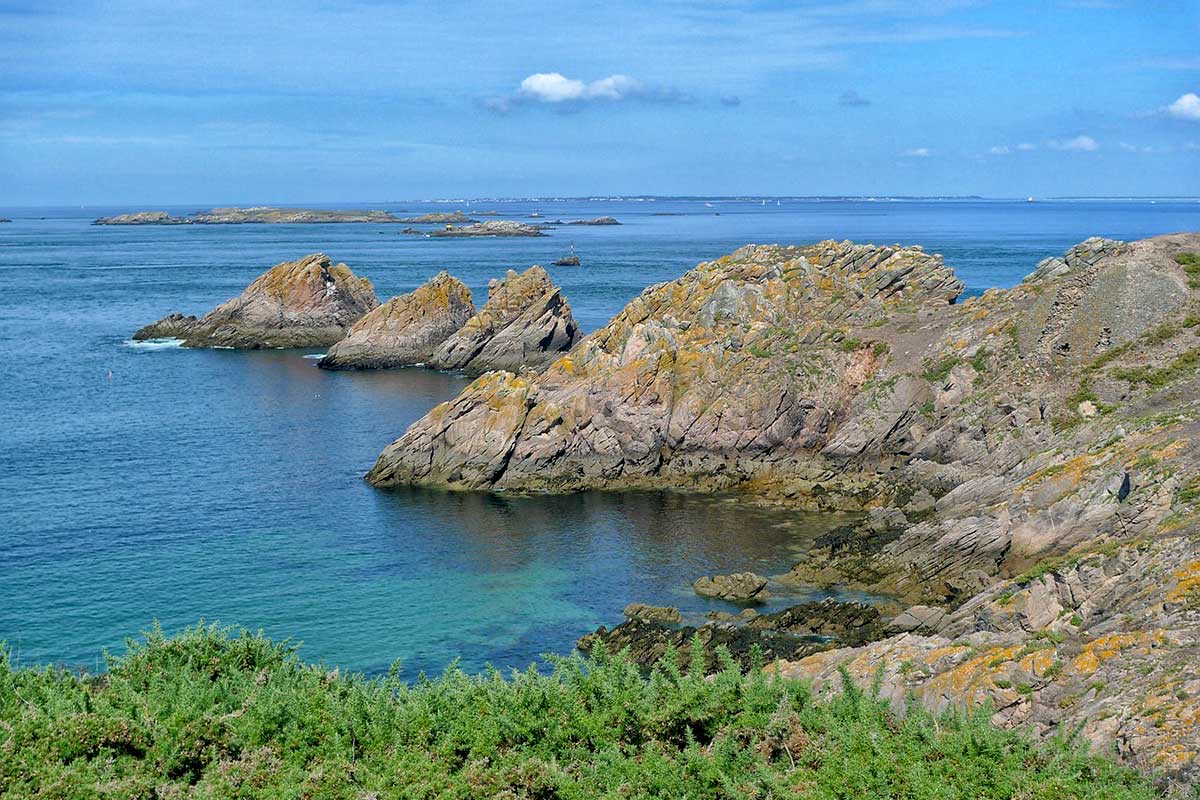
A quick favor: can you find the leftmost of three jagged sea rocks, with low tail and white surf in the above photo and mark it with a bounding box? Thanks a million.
[133,253,379,349]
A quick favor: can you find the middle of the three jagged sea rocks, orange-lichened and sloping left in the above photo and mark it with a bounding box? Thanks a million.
[318,272,475,369]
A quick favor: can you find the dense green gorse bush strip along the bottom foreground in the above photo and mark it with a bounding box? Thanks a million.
[0,624,1154,800]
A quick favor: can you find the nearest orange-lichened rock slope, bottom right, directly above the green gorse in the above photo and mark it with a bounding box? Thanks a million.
[772,528,1200,783]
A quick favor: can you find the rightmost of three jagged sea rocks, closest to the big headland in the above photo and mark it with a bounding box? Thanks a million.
[430,265,581,374]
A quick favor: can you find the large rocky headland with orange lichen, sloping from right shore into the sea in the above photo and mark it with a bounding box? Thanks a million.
[367,234,1200,780]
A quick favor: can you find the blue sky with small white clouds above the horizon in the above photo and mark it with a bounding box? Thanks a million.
[0,0,1200,206]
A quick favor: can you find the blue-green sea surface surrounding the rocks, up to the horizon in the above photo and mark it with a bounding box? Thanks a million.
[0,199,1200,676]
